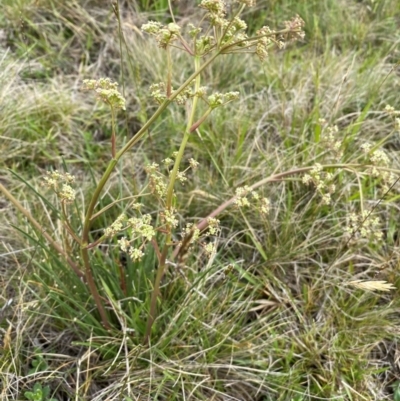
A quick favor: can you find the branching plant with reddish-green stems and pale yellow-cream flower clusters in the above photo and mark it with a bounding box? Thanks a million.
[0,0,395,343]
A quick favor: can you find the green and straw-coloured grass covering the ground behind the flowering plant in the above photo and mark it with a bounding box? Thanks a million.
[0,0,400,401]
